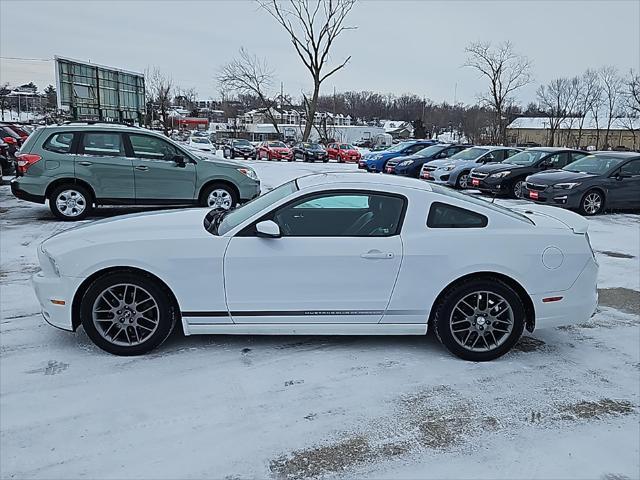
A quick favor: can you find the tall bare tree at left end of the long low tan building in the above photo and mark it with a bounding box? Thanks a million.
[465,42,532,143]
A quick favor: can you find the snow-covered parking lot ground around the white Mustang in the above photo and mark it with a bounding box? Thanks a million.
[0,162,640,479]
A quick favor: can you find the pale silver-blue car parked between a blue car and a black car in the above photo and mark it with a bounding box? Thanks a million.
[420,146,522,188]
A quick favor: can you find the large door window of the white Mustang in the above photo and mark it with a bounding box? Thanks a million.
[273,192,406,237]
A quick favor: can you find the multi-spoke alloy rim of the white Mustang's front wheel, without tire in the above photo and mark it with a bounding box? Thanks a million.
[92,283,160,346]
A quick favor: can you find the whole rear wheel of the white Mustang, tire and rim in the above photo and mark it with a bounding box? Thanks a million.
[433,278,525,362]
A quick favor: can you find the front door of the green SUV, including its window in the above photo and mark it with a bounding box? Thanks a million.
[128,133,196,204]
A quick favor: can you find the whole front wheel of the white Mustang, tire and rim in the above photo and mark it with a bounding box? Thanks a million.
[80,272,175,356]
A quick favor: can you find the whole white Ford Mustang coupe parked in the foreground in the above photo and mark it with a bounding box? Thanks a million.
[34,173,598,361]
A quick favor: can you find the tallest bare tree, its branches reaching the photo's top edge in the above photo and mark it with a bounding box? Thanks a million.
[257,0,356,141]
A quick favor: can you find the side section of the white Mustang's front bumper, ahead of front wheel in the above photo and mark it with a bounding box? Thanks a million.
[31,272,79,331]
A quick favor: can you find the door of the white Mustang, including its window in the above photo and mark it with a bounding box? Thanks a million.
[224,191,407,324]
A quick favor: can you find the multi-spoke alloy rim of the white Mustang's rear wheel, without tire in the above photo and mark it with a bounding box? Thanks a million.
[449,291,514,352]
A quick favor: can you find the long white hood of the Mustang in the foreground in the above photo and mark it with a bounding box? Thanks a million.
[42,208,215,260]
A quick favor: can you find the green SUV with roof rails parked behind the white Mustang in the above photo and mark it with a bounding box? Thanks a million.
[11,123,260,220]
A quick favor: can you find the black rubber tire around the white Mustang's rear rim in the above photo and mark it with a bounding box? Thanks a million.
[433,278,526,362]
